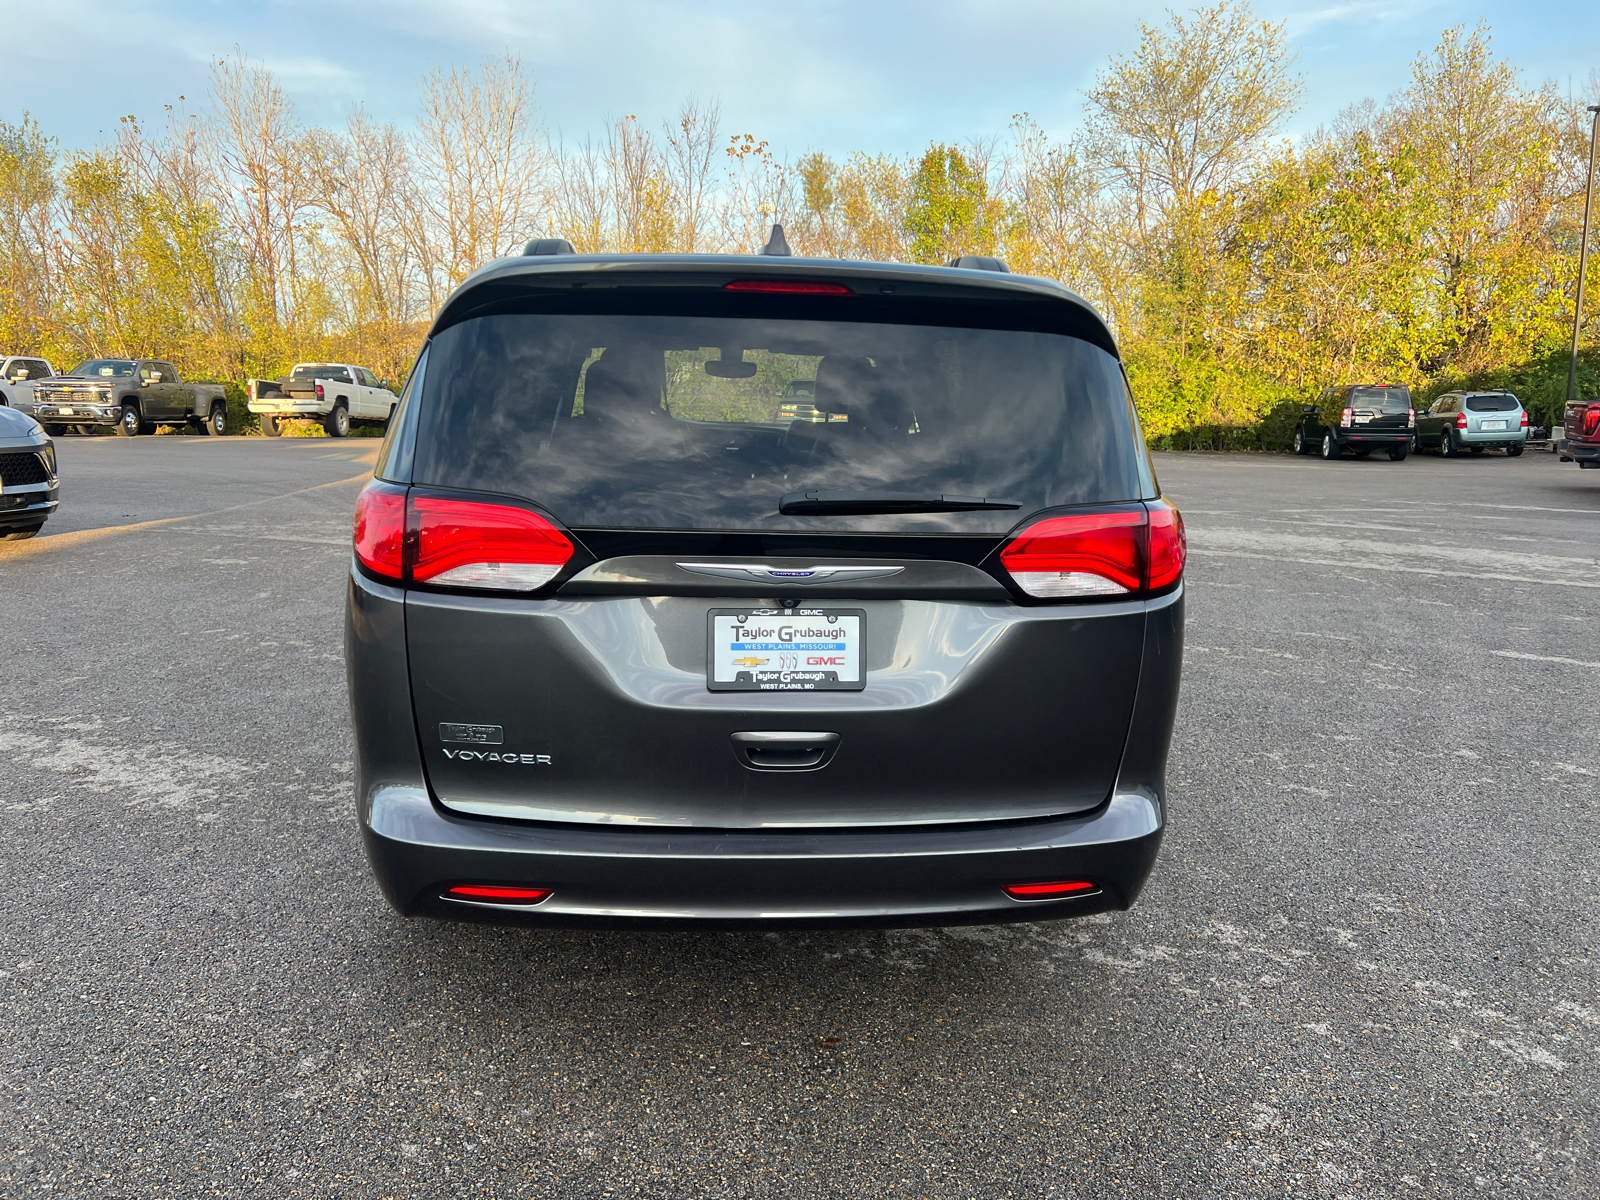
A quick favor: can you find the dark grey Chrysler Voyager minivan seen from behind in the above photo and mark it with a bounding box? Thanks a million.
[346,236,1186,928]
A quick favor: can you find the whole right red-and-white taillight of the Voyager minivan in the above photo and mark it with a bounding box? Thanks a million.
[1000,501,1187,600]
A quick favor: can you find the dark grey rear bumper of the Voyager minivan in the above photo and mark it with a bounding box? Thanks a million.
[362,787,1163,930]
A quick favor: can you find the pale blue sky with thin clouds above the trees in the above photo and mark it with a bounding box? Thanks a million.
[0,0,1600,157]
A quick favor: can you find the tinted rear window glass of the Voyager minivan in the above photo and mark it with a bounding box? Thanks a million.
[413,314,1147,533]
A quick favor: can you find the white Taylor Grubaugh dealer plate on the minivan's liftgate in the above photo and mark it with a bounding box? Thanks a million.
[706,608,867,691]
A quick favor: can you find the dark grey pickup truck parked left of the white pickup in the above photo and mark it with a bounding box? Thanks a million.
[34,358,227,437]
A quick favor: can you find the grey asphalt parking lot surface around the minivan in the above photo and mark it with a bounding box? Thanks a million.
[0,437,1600,1198]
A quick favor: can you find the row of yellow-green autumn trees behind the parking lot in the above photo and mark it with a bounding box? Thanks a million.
[0,3,1595,446]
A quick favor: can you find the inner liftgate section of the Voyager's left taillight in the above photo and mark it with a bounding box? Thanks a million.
[411,496,573,592]
